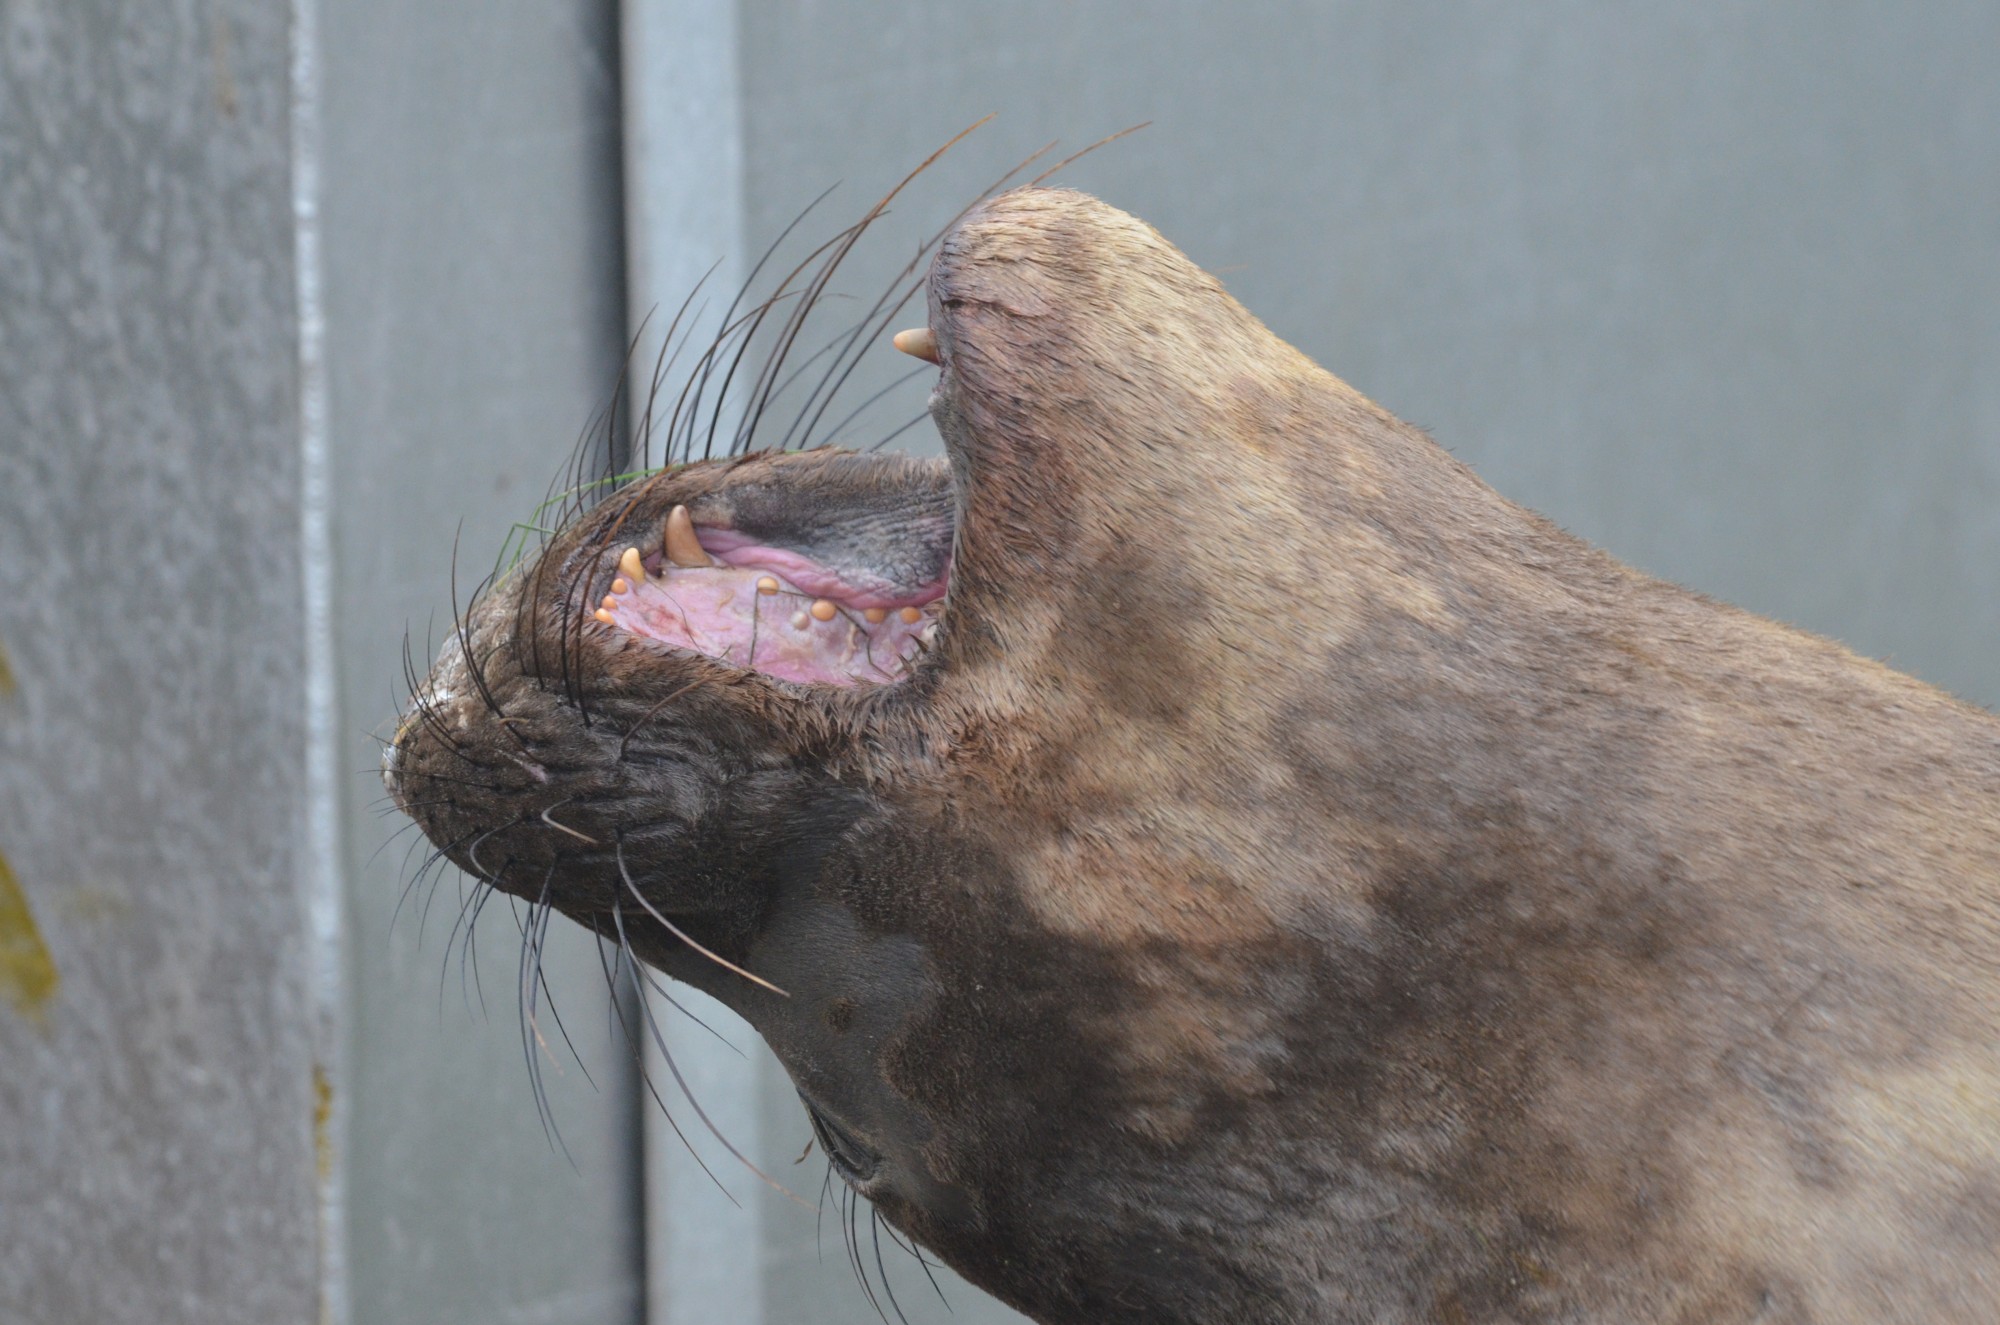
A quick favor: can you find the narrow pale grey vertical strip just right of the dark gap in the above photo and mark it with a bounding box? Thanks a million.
[624,0,1018,1325]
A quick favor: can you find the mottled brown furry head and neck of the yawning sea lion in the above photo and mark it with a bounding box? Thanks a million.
[388,188,2000,1325]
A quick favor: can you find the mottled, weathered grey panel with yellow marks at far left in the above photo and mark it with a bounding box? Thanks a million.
[0,0,318,1325]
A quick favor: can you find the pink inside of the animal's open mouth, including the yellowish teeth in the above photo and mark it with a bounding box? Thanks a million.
[594,504,948,685]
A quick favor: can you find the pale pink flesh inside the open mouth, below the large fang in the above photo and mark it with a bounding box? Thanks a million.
[604,564,932,685]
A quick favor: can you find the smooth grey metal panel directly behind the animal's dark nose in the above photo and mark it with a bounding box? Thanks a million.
[320,0,642,1325]
